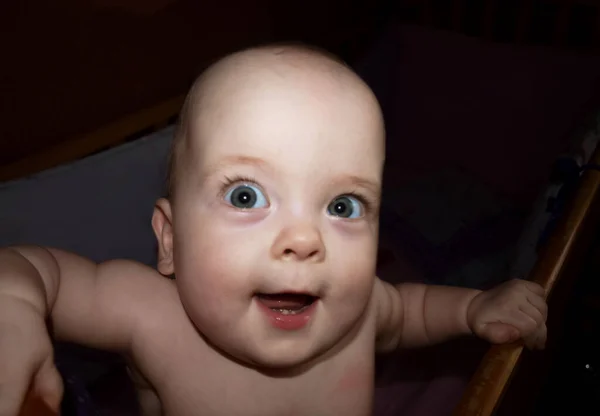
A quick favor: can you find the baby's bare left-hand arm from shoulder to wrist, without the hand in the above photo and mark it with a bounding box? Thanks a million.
[0,246,148,351]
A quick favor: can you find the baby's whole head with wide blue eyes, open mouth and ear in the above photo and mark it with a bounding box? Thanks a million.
[153,45,385,367]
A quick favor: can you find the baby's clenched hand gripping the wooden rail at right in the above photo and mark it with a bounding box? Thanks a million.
[467,279,548,349]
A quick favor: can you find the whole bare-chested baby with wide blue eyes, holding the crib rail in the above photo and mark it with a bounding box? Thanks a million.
[0,45,546,416]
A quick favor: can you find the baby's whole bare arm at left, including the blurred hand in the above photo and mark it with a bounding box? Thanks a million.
[0,246,156,415]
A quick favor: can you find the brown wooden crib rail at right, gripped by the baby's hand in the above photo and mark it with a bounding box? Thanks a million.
[453,146,600,416]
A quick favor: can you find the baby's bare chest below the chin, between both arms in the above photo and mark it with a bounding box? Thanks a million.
[138,316,374,416]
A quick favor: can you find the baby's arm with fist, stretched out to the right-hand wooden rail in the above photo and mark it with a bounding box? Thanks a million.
[374,280,547,351]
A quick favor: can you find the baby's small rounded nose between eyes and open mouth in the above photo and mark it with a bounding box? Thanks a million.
[272,223,325,262]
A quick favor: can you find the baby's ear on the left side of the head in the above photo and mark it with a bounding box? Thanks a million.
[152,198,175,276]
